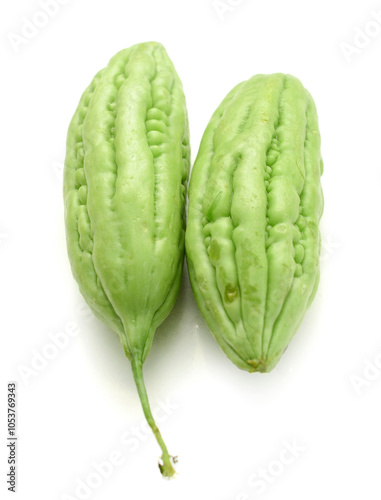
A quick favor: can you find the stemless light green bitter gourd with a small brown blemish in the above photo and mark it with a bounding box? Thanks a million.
[185,74,323,372]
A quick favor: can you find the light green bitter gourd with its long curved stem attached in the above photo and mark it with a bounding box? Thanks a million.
[64,42,190,476]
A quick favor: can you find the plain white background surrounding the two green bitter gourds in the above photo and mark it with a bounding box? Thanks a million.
[0,0,381,500]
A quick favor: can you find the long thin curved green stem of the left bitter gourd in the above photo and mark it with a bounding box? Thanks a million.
[131,356,176,477]
